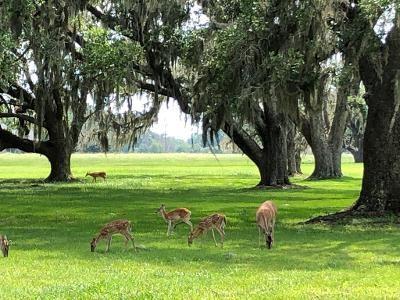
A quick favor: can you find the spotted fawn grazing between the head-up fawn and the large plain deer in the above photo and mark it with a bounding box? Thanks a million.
[188,214,226,247]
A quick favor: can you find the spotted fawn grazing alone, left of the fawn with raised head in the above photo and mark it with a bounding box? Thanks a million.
[90,220,136,252]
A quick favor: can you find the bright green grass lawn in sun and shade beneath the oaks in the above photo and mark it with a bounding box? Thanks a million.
[0,154,400,299]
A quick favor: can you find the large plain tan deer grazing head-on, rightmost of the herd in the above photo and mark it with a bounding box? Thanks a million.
[256,201,277,249]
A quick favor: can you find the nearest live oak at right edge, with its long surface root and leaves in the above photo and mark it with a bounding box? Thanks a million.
[309,1,400,222]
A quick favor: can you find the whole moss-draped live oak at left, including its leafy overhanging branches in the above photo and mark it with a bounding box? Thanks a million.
[0,0,159,181]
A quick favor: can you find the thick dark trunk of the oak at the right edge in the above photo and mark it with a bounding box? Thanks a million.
[353,11,400,213]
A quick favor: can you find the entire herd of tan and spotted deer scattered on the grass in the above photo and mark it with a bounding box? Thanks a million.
[0,172,277,257]
